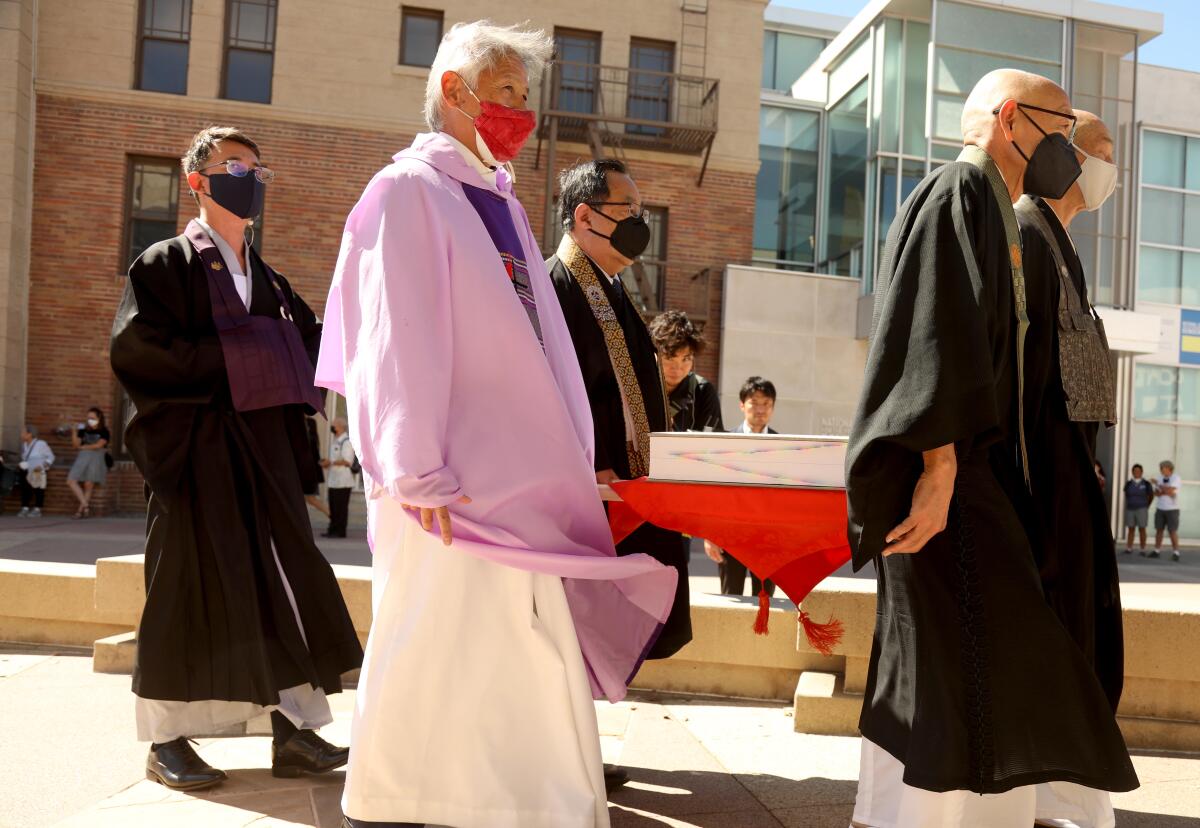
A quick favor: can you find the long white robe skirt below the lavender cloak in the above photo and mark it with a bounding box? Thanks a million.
[342,497,608,828]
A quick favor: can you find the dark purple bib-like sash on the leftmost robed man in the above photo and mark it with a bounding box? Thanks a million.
[184,220,324,412]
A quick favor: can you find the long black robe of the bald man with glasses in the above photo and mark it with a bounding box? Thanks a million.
[846,162,1138,793]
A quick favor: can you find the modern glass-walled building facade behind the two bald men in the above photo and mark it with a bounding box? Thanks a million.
[754,0,1142,306]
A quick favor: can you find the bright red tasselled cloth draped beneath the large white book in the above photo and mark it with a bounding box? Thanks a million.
[608,478,850,640]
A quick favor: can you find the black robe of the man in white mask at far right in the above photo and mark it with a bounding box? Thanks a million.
[1018,198,1124,710]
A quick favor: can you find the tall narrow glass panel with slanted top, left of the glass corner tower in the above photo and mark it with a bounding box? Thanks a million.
[820,80,868,277]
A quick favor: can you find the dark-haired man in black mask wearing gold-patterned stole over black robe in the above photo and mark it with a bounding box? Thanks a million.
[546,160,691,659]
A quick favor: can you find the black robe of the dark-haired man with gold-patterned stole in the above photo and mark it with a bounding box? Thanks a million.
[546,256,691,659]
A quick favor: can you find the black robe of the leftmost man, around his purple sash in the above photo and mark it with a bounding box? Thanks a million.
[112,235,362,706]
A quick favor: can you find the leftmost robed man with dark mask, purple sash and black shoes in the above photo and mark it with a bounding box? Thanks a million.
[112,127,362,790]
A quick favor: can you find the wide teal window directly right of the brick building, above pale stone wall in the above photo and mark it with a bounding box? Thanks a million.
[754,107,821,270]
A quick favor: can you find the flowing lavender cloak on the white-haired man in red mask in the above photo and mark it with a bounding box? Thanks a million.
[317,133,677,701]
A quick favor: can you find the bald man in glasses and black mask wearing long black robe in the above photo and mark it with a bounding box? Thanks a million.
[846,70,1138,826]
